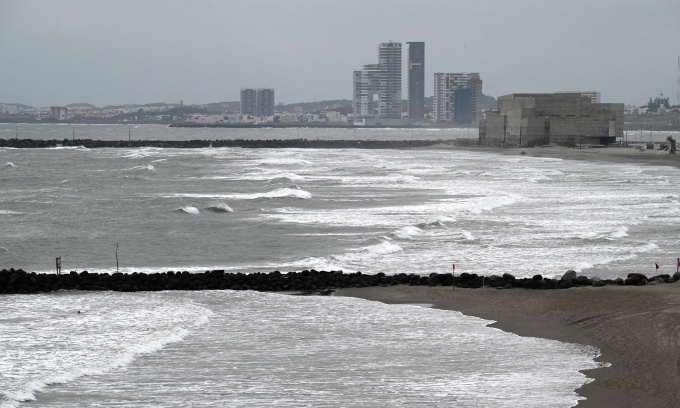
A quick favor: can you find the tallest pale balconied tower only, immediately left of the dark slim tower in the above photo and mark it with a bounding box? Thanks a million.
[378,41,401,119]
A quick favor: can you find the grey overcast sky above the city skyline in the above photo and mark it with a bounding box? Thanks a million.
[0,0,680,106]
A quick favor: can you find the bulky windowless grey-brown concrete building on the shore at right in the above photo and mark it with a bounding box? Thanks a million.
[479,93,623,146]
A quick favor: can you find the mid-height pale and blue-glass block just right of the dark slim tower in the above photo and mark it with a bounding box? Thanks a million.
[432,72,482,124]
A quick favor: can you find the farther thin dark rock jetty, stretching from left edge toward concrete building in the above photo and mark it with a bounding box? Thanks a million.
[0,139,444,149]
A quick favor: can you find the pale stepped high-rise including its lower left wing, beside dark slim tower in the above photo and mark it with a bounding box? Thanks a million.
[353,41,401,119]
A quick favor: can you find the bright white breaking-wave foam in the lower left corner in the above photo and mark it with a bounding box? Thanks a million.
[0,292,211,407]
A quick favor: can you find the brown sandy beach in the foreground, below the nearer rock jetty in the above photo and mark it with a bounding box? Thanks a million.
[338,284,680,408]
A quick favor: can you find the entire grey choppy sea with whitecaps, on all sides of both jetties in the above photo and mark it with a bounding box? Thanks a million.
[0,125,680,407]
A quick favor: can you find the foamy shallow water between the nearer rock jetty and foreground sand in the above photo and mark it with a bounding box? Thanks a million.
[0,291,598,407]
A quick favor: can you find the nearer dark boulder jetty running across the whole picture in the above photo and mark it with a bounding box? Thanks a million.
[0,269,680,294]
